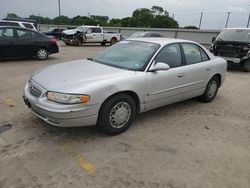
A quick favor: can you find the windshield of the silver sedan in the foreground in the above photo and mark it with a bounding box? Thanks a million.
[93,40,160,71]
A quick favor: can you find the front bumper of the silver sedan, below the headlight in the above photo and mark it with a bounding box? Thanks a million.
[23,83,99,127]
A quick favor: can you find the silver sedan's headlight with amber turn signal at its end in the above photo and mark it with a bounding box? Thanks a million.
[47,91,90,104]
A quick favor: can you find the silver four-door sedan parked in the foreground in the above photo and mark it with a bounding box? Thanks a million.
[24,38,227,134]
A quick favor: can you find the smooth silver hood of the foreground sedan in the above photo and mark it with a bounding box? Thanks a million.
[32,60,135,93]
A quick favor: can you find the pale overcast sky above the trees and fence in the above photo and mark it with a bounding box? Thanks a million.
[0,0,250,29]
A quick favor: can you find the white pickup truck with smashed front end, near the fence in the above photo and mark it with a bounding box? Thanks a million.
[62,25,121,46]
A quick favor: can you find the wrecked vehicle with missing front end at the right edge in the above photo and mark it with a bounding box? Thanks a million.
[210,28,250,72]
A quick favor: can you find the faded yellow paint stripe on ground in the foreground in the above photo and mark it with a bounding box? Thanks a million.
[62,143,96,173]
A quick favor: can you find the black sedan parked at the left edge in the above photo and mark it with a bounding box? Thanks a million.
[0,26,59,60]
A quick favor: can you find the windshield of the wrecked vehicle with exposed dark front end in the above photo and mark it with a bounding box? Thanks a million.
[217,29,250,42]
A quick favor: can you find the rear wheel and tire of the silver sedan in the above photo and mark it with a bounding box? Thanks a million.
[200,77,219,102]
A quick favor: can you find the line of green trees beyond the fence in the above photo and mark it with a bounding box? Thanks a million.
[7,6,196,29]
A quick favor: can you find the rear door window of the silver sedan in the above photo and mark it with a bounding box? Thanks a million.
[182,44,202,65]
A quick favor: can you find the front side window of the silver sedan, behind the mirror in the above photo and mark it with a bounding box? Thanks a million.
[155,44,182,68]
